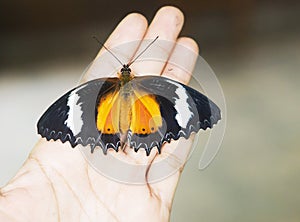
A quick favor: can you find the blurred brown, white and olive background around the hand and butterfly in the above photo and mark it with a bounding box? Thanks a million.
[0,0,300,222]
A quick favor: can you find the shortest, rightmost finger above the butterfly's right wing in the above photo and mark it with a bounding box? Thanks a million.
[162,37,199,84]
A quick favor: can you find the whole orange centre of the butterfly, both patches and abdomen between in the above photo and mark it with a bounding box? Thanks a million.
[96,91,162,135]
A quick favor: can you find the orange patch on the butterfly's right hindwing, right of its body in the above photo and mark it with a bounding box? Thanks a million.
[130,92,162,134]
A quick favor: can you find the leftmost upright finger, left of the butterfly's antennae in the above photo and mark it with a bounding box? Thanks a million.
[82,13,148,82]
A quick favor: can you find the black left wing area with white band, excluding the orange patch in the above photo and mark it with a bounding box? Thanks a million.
[37,78,120,153]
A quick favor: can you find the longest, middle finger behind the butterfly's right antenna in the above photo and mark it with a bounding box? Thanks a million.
[132,6,184,75]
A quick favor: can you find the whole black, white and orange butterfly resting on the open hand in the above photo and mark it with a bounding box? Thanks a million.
[37,39,221,156]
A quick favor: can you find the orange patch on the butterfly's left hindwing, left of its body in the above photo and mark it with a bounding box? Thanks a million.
[97,92,120,134]
